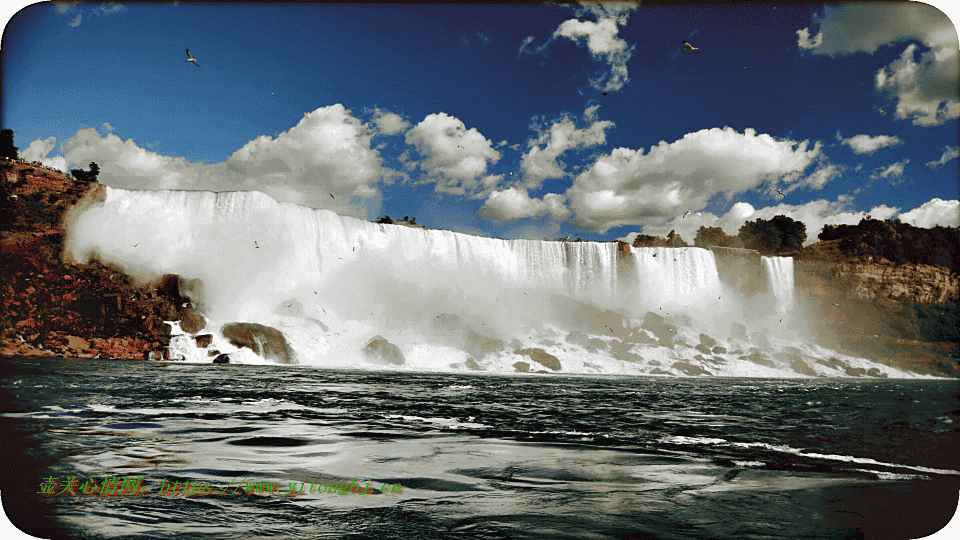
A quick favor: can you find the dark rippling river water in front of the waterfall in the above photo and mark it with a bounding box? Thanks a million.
[0,359,960,539]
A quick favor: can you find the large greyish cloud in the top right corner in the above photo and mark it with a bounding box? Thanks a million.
[797,2,960,126]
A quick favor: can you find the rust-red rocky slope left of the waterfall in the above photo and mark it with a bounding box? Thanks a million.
[0,160,186,359]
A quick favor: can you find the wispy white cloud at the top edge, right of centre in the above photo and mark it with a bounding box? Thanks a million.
[548,2,637,92]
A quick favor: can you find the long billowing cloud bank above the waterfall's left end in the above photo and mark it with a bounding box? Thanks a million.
[24,104,397,217]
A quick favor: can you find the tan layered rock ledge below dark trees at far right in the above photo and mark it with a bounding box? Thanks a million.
[794,260,960,304]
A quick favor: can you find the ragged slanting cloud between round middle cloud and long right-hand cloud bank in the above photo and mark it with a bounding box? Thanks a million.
[520,106,614,189]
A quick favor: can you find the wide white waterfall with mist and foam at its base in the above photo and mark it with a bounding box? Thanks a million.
[66,188,924,376]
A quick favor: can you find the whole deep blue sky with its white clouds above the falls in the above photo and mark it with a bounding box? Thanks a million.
[2,2,960,243]
